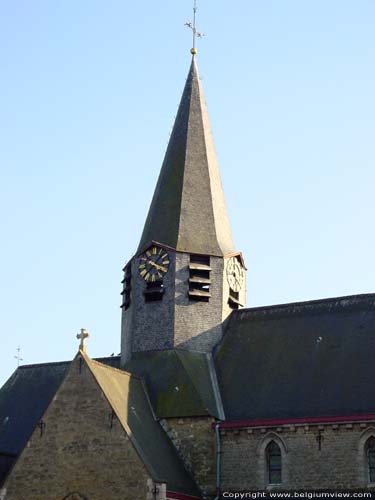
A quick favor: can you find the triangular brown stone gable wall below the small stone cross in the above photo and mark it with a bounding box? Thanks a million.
[3,358,150,500]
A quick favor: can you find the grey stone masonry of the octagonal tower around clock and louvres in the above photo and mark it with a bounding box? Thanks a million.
[121,250,246,364]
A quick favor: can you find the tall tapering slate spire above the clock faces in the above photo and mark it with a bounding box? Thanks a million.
[138,57,234,256]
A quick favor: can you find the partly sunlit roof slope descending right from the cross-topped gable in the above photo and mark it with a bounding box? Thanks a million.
[81,352,200,497]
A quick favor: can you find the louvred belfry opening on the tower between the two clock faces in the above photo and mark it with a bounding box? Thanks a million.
[189,255,211,302]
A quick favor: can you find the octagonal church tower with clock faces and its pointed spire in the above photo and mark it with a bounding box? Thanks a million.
[121,53,246,363]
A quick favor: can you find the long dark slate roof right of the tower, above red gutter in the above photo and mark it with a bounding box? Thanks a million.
[215,294,375,421]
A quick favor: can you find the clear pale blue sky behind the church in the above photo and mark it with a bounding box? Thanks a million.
[0,0,375,383]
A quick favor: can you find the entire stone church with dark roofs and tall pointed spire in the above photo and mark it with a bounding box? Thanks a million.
[0,45,375,500]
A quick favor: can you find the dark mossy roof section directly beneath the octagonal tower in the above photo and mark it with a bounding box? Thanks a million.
[125,349,224,419]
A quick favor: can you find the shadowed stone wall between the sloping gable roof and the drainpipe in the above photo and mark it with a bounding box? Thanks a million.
[161,417,216,496]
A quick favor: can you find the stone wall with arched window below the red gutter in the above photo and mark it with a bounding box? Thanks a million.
[221,422,375,491]
